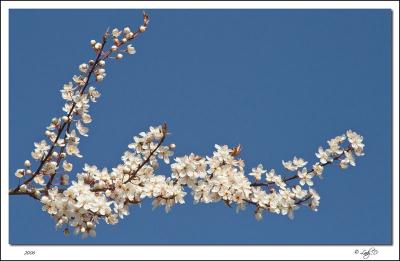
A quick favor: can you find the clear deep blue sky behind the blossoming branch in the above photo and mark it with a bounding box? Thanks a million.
[7,10,392,245]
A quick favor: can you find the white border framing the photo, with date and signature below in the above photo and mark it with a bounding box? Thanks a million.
[1,1,399,260]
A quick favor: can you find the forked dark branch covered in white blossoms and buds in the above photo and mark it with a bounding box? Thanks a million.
[9,13,364,237]
